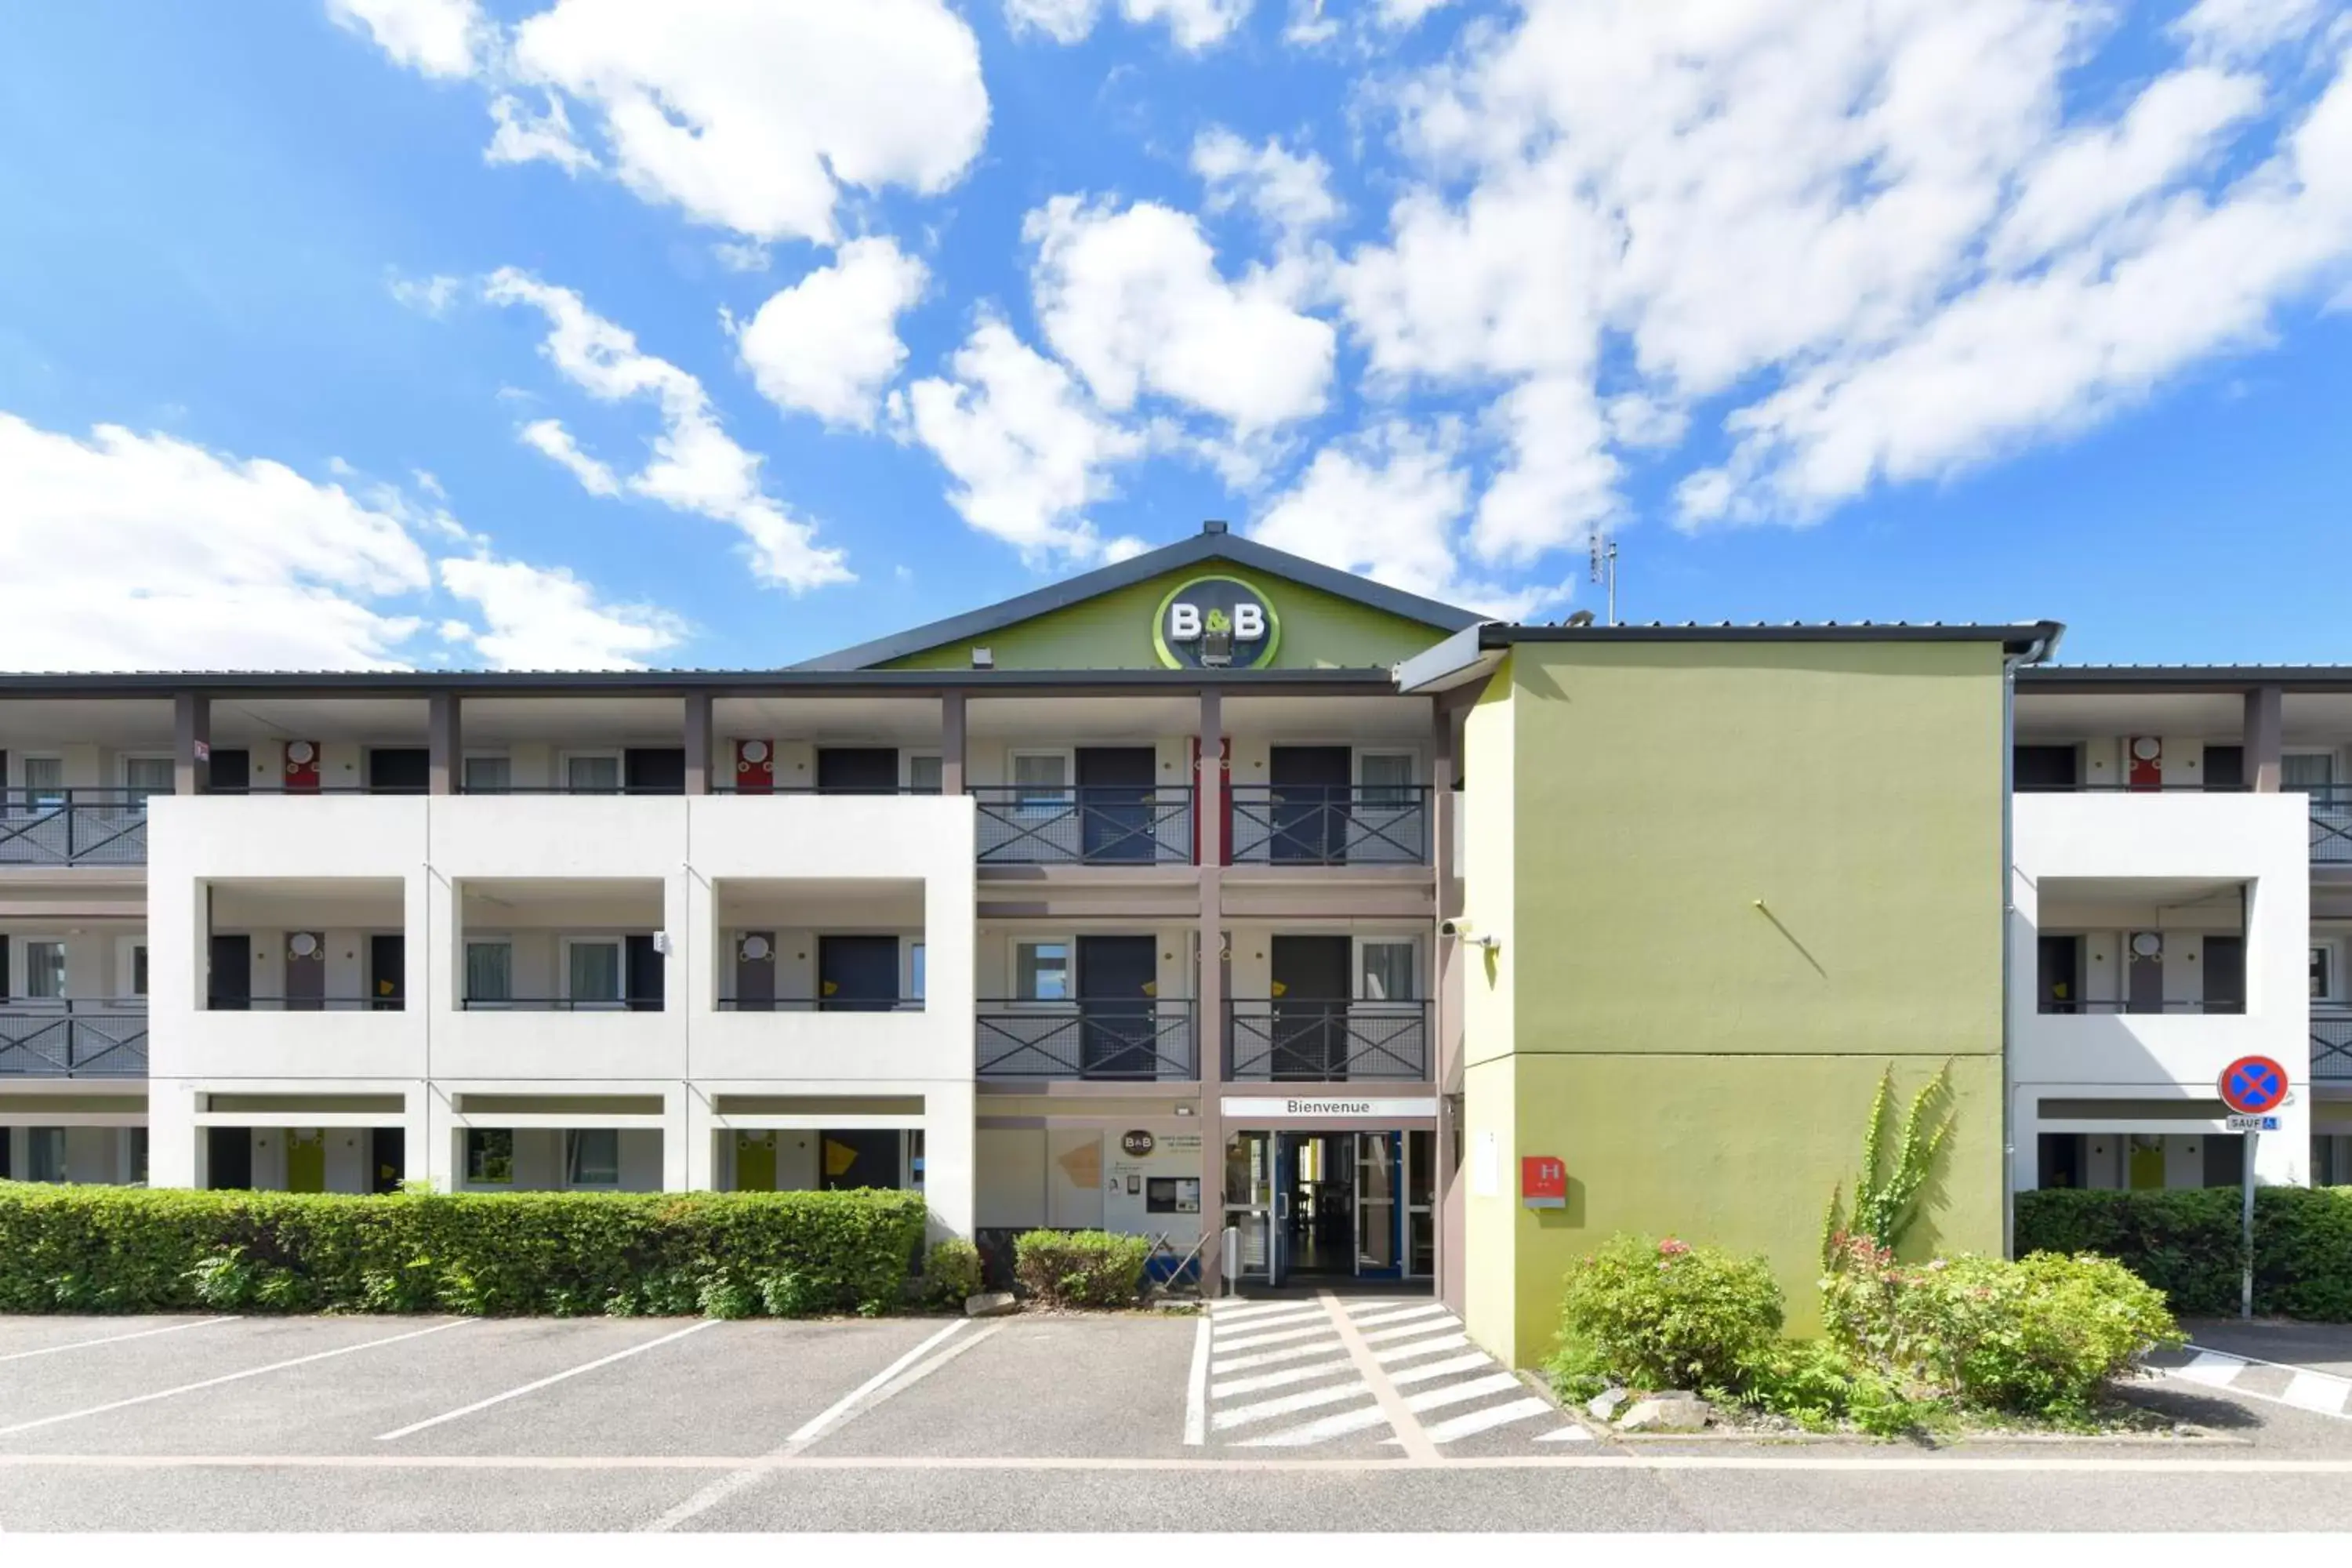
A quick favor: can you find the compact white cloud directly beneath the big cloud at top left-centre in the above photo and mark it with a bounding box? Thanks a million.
[739,240,929,430]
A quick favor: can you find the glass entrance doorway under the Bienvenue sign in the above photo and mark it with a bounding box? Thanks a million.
[1225,1131,1435,1286]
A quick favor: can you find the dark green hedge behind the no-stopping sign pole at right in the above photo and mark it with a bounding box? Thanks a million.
[2016,1187,2352,1323]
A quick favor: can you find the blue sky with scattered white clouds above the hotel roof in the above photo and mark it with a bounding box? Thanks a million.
[0,0,2352,668]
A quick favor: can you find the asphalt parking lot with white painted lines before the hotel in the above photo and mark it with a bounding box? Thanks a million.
[0,1298,2352,1530]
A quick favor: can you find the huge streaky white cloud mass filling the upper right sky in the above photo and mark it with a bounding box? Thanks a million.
[1334,0,2352,552]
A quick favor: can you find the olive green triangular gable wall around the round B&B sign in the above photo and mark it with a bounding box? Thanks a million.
[882,562,1446,670]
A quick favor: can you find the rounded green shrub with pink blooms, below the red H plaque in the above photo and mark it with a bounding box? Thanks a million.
[1559,1236,1783,1389]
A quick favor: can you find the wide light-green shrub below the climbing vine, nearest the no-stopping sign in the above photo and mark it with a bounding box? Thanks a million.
[1823,1239,2180,1420]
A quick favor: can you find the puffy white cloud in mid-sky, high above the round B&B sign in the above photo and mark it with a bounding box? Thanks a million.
[1023,195,1336,430]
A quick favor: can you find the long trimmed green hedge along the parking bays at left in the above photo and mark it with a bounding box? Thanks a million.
[0,1182,924,1316]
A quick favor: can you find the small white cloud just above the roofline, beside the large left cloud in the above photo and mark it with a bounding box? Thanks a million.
[440,555,687,670]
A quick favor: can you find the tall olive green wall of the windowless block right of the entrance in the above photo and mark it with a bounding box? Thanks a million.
[1463,637,2002,1361]
